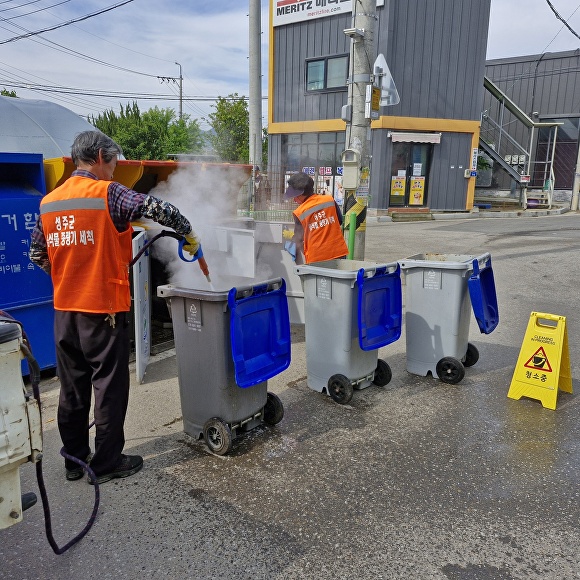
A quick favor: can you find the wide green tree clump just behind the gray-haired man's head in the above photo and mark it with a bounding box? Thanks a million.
[89,102,203,159]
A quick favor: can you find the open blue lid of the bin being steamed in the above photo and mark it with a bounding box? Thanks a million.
[228,278,290,388]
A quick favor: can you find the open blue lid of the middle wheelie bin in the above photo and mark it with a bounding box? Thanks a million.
[356,262,403,350]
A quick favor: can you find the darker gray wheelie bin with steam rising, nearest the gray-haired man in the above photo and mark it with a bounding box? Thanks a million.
[157,278,290,455]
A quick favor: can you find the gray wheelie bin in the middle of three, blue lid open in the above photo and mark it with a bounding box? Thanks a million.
[295,260,402,404]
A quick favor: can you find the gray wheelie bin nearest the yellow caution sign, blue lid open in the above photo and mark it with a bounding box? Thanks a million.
[399,253,499,384]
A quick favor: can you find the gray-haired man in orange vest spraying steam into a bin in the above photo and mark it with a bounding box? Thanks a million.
[30,131,199,483]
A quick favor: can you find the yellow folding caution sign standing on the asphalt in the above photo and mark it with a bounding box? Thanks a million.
[508,312,572,410]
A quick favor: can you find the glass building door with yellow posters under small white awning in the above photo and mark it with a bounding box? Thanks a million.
[389,142,433,207]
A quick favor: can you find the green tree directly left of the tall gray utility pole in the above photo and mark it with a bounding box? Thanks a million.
[208,93,250,163]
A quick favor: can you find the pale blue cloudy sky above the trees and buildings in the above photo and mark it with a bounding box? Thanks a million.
[0,0,580,128]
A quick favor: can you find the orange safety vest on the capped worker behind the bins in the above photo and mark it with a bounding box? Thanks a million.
[293,194,348,264]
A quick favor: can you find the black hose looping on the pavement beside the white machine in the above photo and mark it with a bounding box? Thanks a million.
[15,342,101,555]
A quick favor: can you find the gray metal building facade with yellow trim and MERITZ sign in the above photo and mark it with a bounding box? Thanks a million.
[268,0,490,211]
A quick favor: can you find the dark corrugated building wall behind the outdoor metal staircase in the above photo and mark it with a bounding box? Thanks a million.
[484,49,580,189]
